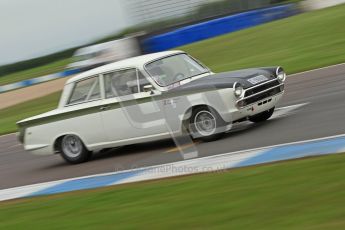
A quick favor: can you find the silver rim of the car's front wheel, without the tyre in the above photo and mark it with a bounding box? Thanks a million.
[194,110,217,136]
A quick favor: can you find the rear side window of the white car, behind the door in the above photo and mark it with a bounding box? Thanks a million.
[68,77,101,105]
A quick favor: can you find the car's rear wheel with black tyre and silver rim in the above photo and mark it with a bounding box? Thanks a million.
[60,135,91,164]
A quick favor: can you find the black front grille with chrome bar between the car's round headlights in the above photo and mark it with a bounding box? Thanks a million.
[237,79,284,107]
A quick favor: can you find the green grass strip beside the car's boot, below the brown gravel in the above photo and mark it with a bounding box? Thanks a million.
[0,92,61,135]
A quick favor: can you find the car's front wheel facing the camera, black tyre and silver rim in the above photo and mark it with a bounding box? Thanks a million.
[189,107,225,142]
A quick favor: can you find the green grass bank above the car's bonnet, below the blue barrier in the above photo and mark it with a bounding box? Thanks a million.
[179,4,345,73]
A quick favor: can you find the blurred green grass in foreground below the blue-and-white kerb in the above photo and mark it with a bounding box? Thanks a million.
[0,154,345,229]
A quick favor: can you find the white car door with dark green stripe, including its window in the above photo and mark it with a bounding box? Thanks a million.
[102,68,167,142]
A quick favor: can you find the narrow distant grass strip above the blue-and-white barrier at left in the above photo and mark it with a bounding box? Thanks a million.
[0,58,70,86]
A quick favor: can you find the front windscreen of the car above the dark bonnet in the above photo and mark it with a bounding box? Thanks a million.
[145,54,209,87]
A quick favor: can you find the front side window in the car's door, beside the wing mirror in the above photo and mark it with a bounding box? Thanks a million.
[104,69,150,98]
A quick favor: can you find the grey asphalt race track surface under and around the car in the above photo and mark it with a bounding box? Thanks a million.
[0,64,345,189]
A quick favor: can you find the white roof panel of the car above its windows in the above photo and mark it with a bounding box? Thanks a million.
[66,50,184,84]
